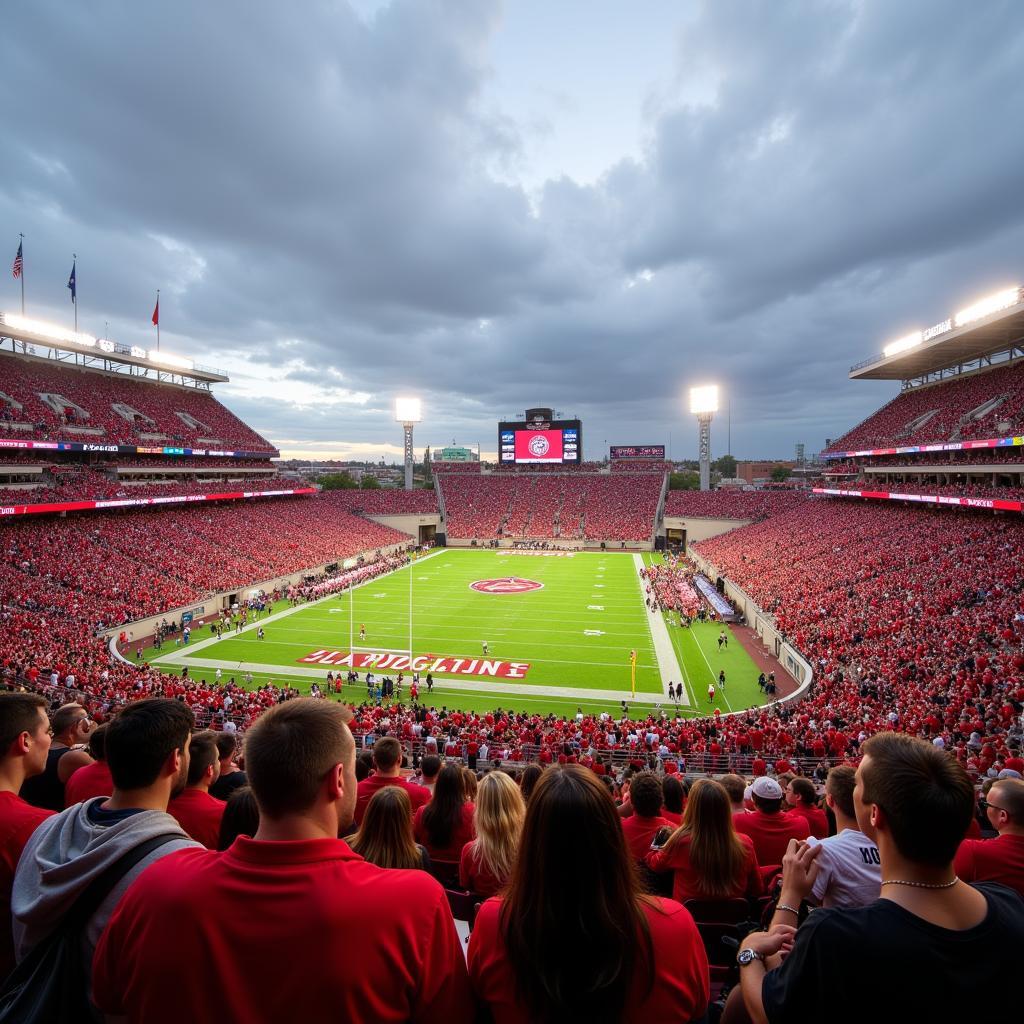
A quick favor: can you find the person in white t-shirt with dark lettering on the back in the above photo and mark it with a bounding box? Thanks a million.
[808,765,882,908]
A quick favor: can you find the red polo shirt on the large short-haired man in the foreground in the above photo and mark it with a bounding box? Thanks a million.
[92,836,473,1024]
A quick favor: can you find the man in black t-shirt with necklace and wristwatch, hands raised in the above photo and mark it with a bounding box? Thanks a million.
[723,733,1024,1024]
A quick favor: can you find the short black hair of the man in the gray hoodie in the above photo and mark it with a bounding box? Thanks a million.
[105,697,196,790]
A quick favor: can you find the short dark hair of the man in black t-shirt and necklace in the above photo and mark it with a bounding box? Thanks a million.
[860,732,975,867]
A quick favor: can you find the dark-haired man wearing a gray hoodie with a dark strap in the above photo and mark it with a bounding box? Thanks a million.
[11,697,197,983]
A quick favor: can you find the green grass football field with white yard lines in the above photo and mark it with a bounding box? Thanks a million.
[145,550,763,715]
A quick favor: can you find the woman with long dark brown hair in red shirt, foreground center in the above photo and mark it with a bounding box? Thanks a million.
[469,765,710,1024]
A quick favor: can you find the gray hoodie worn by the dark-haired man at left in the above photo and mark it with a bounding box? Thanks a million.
[10,797,203,964]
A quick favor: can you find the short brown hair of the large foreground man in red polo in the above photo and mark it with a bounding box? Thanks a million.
[246,697,354,818]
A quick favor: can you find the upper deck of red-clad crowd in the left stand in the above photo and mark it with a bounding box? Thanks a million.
[0,352,273,452]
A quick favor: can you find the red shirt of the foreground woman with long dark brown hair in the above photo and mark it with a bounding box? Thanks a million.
[468,897,710,1024]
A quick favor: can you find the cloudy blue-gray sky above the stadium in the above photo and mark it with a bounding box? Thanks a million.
[0,0,1024,458]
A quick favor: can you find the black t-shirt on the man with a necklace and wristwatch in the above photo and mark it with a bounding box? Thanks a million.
[761,883,1024,1024]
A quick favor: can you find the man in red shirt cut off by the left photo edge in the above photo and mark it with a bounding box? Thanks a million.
[0,693,53,980]
